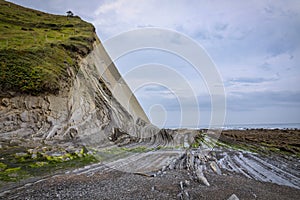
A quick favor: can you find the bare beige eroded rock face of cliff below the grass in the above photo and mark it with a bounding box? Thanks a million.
[0,41,162,150]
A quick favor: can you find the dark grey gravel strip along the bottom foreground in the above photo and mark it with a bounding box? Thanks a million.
[0,170,300,200]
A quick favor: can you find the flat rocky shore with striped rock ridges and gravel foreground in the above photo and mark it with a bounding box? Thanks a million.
[0,129,300,200]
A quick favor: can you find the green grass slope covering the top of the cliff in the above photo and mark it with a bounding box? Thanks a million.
[0,0,95,96]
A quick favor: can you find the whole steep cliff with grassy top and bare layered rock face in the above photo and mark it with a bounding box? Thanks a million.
[0,1,161,152]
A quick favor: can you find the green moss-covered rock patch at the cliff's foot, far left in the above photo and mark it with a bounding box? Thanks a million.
[0,147,99,182]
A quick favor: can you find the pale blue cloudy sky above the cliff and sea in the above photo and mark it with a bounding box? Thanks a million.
[7,0,300,127]
